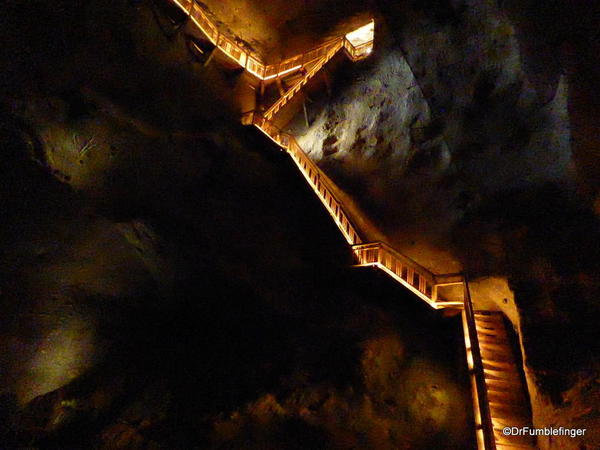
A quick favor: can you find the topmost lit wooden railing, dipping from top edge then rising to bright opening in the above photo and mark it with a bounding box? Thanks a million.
[172,0,373,81]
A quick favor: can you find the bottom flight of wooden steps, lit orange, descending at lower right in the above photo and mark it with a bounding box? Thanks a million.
[473,311,535,450]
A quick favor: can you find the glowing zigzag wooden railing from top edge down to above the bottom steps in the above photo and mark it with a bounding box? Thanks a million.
[173,0,461,308]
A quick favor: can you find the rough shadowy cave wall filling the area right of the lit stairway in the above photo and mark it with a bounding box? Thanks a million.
[296,1,599,448]
